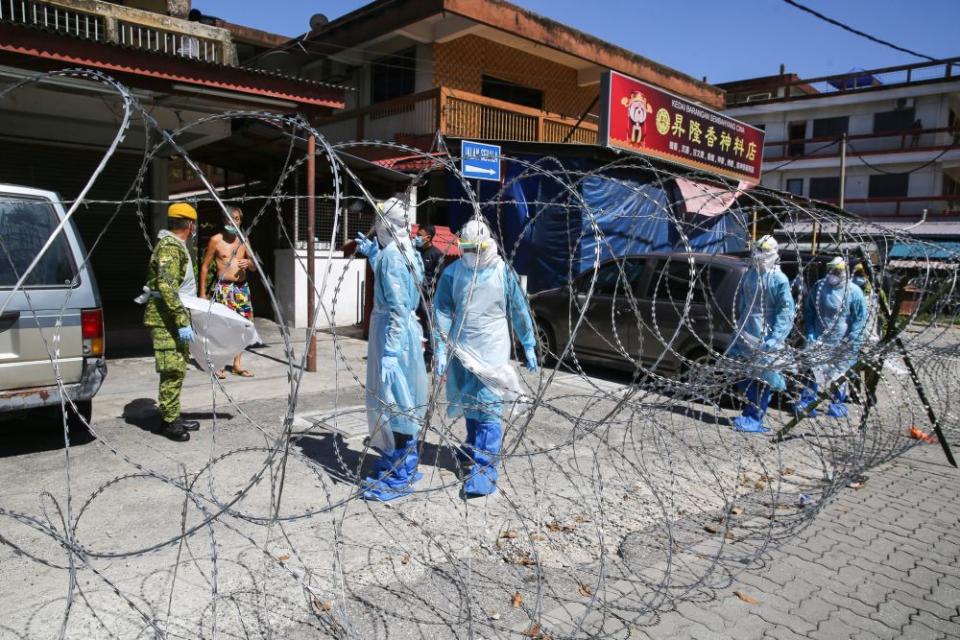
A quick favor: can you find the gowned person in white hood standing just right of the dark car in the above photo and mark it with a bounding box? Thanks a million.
[727,236,796,433]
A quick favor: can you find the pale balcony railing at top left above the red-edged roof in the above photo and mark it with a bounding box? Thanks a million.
[0,0,236,64]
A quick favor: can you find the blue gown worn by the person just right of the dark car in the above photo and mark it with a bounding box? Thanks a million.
[727,266,796,391]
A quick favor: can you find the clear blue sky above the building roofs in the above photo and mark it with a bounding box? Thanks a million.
[193,0,960,82]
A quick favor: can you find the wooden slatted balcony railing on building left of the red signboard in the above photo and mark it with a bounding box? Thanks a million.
[317,87,598,144]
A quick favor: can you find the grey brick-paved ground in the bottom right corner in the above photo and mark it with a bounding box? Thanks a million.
[641,445,960,640]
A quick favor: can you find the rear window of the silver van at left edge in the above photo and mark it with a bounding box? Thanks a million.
[0,196,77,289]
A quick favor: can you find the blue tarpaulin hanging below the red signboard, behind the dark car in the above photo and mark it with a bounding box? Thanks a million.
[448,157,746,293]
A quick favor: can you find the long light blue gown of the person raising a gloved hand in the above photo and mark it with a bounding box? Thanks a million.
[366,242,427,452]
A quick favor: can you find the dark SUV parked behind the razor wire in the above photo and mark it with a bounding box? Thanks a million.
[530,253,749,377]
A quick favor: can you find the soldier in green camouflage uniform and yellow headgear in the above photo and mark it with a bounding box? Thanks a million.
[143,203,200,442]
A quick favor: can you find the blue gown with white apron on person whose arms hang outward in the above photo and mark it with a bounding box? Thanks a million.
[433,260,537,422]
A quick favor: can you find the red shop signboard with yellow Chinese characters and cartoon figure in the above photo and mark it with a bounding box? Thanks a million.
[600,71,763,184]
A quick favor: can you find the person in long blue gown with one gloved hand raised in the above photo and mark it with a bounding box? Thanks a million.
[357,198,427,501]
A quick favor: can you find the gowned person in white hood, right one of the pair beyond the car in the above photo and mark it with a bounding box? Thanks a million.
[794,261,869,418]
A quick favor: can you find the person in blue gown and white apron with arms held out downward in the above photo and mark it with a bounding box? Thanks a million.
[433,219,538,497]
